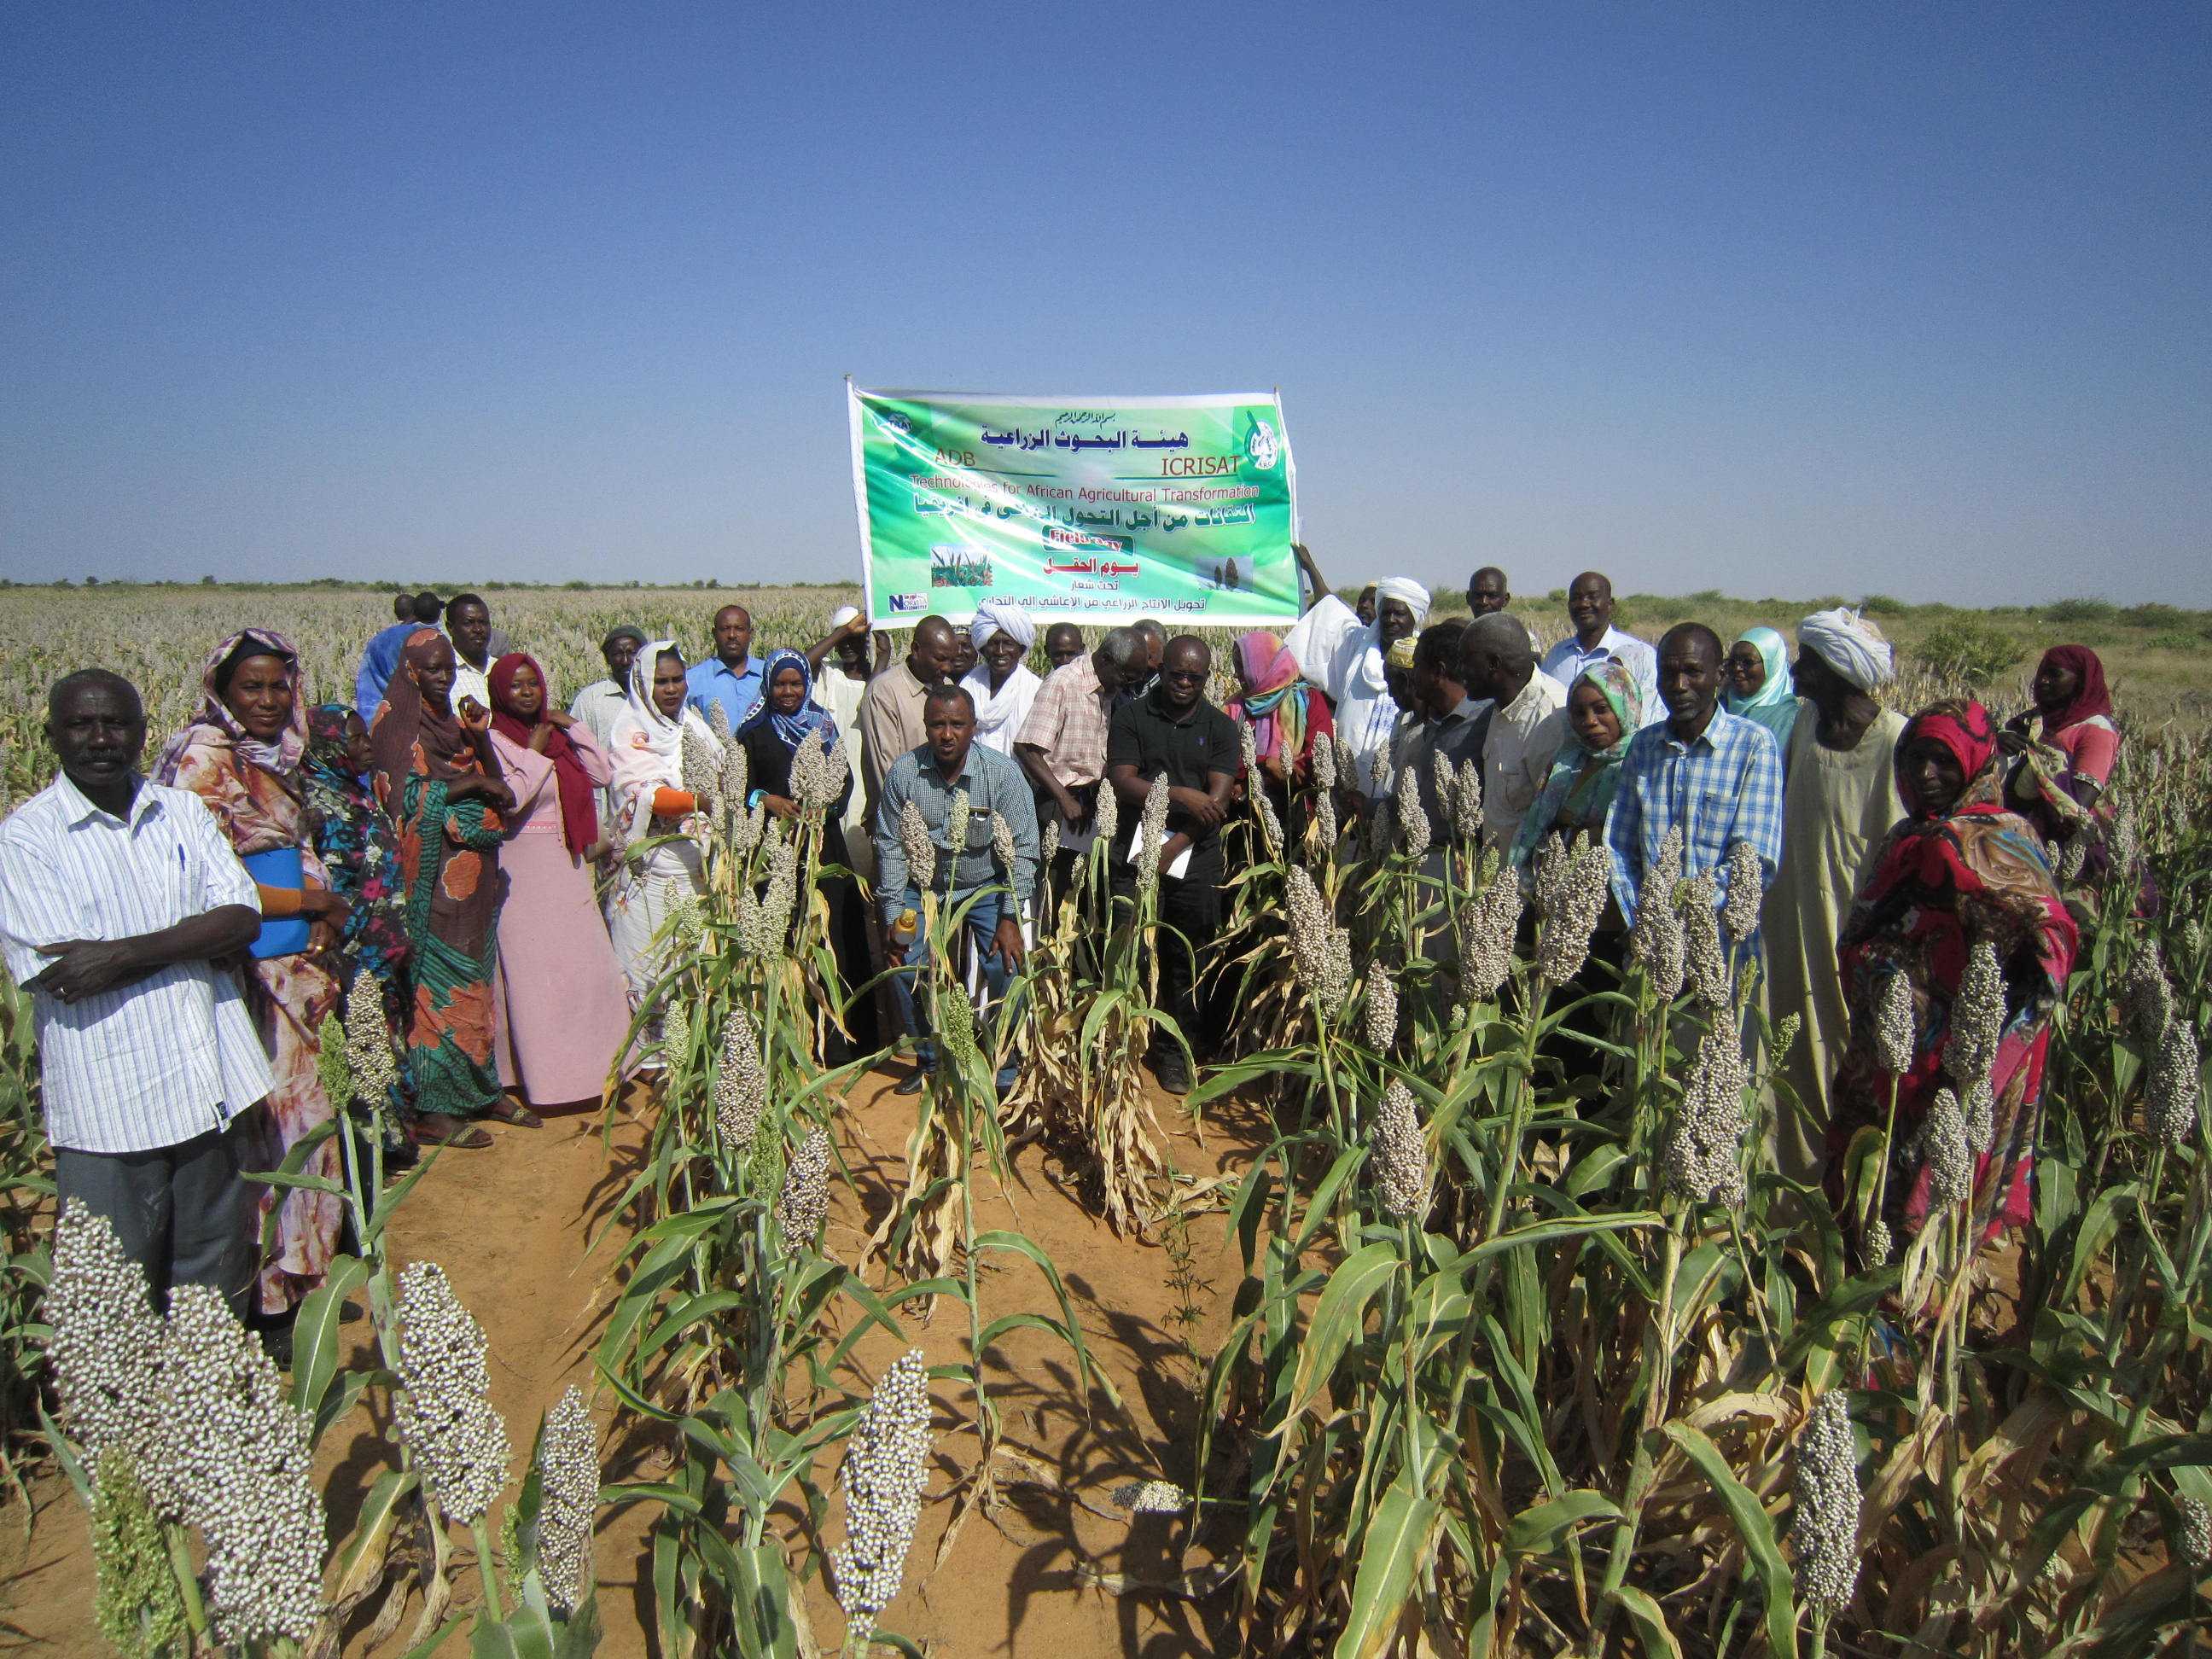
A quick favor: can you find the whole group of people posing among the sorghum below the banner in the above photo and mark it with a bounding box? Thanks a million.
[0,570,2119,1342]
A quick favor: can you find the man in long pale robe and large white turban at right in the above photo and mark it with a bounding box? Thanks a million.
[1761,608,1905,1181]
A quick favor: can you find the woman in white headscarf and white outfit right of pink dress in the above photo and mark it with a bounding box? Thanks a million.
[606,639,721,1009]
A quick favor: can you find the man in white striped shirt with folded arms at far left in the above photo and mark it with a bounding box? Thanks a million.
[0,668,270,1307]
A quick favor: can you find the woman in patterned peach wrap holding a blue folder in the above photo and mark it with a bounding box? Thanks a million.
[154,628,347,1358]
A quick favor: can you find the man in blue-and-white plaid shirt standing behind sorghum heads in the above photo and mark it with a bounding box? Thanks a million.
[1606,621,1783,923]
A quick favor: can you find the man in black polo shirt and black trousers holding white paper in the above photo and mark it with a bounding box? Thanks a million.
[1106,632,1243,1095]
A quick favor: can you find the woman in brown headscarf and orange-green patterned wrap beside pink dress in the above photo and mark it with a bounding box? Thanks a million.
[370,628,535,1124]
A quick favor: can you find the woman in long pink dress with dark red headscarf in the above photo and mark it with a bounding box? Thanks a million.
[491,650,631,1106]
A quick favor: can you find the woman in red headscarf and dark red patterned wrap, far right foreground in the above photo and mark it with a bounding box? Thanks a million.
[1827,699,2077,1239]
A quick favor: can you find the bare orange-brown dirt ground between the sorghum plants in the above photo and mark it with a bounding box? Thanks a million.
[0,1066,1260,1659]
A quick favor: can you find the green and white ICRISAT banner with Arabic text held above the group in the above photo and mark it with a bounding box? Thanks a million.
[845,381,1299,628]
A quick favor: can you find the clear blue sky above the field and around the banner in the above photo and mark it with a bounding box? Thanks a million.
[0,0,2212,606]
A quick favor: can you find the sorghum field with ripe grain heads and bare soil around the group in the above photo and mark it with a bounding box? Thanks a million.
[0,586,2212,1659]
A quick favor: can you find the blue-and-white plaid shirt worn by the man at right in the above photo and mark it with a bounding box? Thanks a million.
[1606,707,1783,923]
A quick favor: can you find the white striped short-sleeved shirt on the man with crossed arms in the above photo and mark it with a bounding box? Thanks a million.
[0,774,270,1152]
